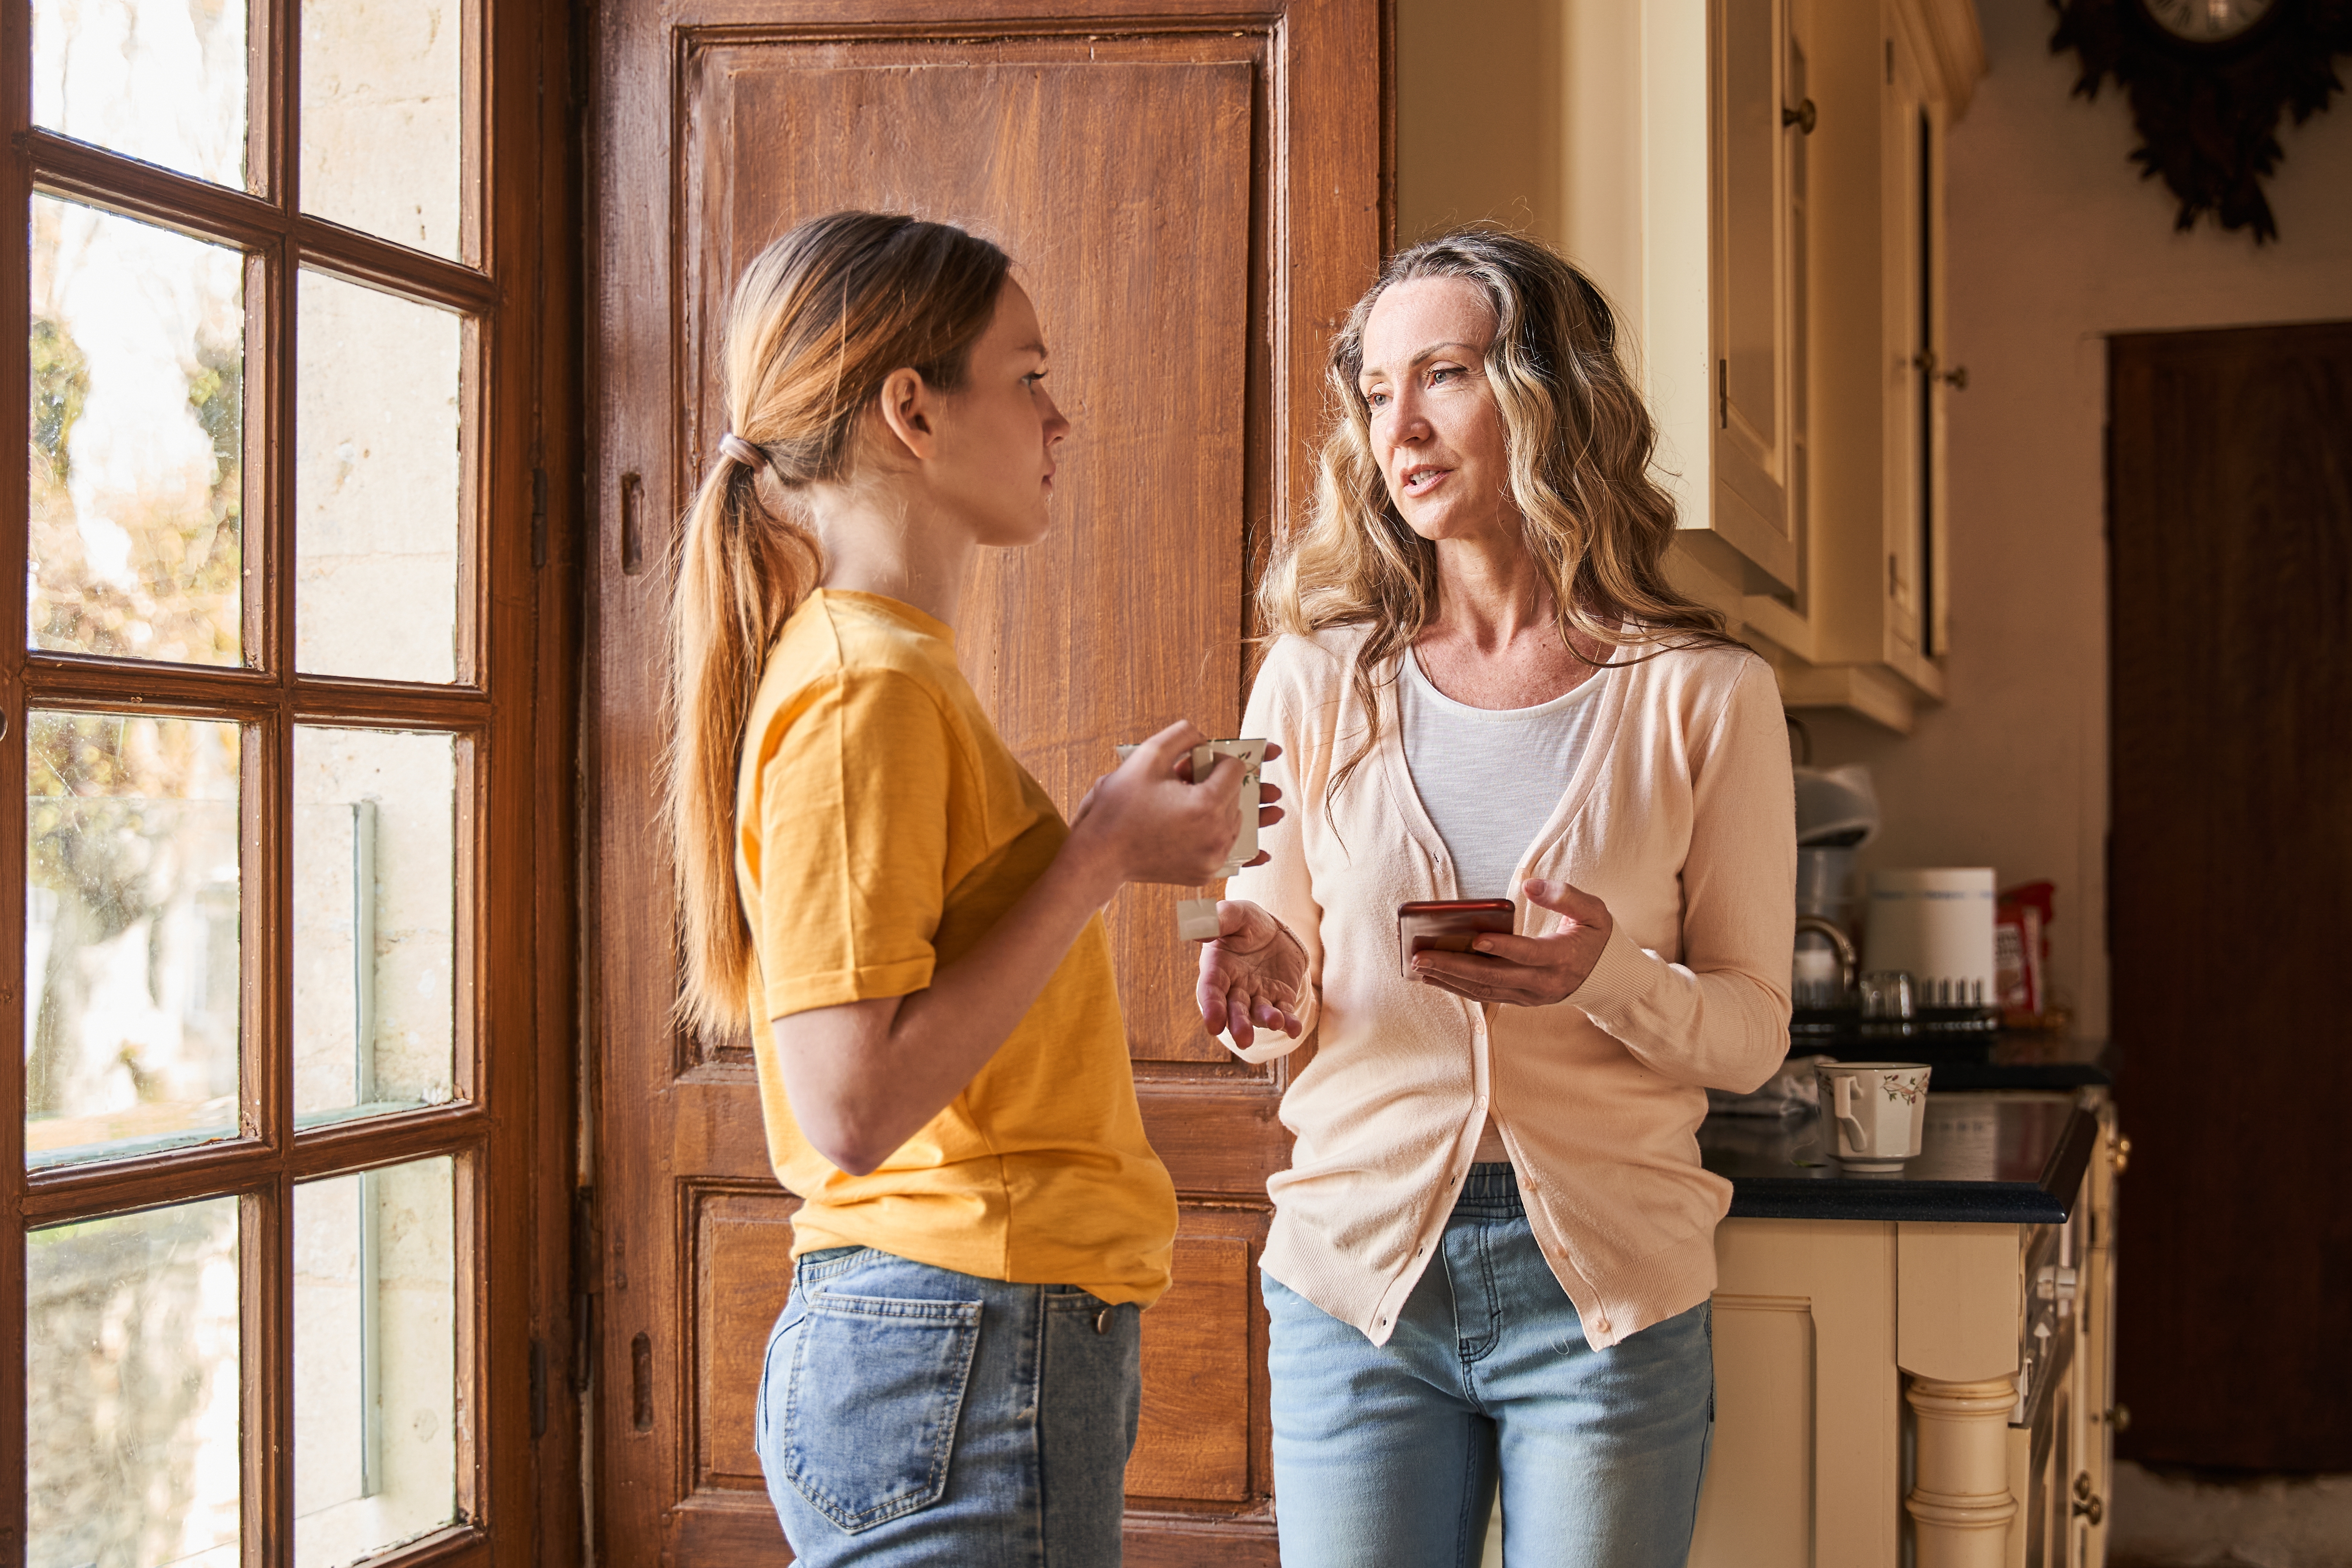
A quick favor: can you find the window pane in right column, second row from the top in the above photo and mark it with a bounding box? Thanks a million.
[294,273,463,682]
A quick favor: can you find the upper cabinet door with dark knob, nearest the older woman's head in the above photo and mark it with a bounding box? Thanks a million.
[1710,0,1797,588]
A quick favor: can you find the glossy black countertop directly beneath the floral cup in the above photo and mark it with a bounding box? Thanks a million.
[1698,1058,2107,1225]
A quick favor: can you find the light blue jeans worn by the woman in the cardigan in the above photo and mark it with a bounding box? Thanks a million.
[1263,1164,1715,1568]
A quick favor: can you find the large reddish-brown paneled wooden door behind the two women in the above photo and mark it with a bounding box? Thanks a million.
[583,0,1383,1566]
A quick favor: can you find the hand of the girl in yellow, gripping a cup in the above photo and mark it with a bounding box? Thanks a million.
[1070,719,1282,886]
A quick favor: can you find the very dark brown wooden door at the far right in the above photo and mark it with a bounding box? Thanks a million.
[2107,322,2352,1472]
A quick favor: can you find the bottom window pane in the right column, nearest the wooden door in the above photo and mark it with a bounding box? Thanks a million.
[294,1157,459,1568]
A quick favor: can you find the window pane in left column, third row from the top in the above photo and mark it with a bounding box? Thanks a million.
[24,712,238,1166]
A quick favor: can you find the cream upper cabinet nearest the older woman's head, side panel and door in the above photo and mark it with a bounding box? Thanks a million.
[1552,0,1816,602]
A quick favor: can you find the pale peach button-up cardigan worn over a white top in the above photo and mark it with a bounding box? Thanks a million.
[1225,630,1797,1349]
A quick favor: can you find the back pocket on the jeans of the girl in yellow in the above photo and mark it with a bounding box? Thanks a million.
[783,1290,981,1535]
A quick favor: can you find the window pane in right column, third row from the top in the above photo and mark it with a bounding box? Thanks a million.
[294,729,456,1124]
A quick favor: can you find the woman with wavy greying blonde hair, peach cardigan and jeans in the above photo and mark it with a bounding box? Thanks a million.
[1200,230,1795,1568]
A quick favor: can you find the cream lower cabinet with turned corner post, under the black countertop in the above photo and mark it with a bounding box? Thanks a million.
[1691,1105,2117,1568]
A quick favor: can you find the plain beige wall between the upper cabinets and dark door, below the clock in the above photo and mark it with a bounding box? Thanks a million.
[1806,0,2352,1037]
